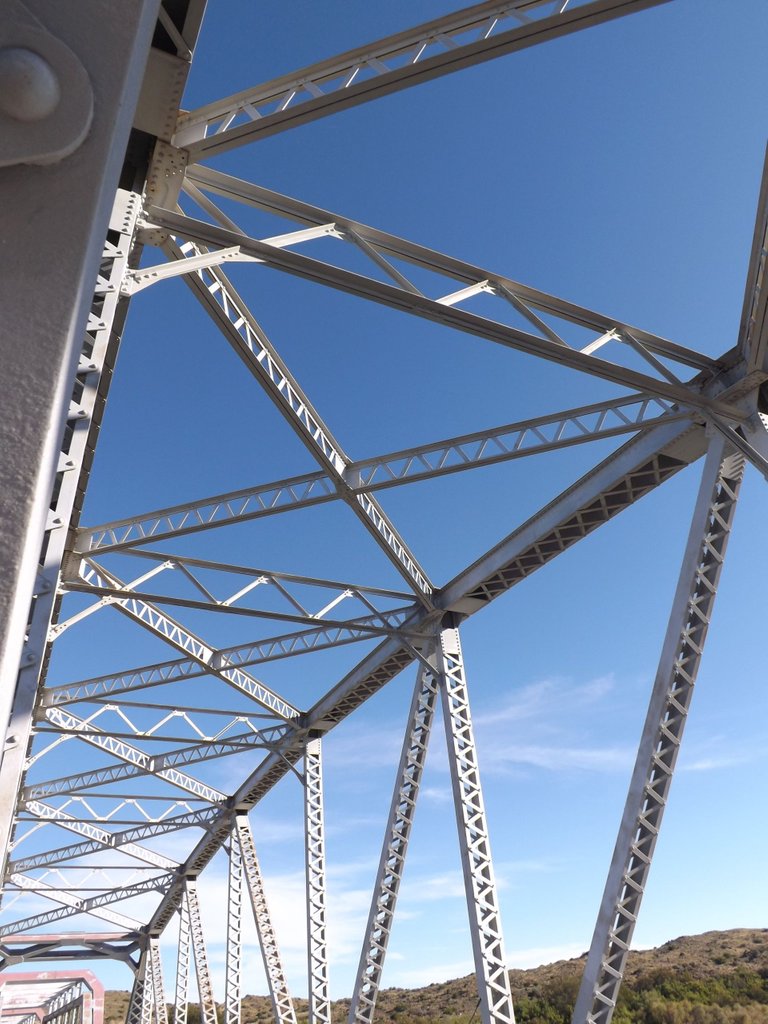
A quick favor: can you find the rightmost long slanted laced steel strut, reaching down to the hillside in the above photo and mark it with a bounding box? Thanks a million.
[573,434,744,1024]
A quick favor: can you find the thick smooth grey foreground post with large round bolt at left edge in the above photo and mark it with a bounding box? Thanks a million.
[0,0,160,770]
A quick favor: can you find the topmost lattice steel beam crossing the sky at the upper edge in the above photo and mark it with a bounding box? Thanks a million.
[173,0,666,161]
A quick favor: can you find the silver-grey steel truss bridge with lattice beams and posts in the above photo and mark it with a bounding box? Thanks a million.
[0,6,768,1024]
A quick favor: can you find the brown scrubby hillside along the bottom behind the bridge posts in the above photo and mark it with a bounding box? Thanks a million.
[104,928,768,1024]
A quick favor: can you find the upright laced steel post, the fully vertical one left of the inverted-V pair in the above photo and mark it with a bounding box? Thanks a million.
[304,736,331,1024]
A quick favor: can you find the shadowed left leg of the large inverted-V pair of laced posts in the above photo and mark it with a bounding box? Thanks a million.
[349,665,437,1024]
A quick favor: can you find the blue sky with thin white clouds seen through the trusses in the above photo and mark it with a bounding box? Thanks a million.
[9,0,768,997]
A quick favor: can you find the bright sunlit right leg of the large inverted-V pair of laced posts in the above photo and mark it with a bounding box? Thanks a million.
[437,616,515,1024]
